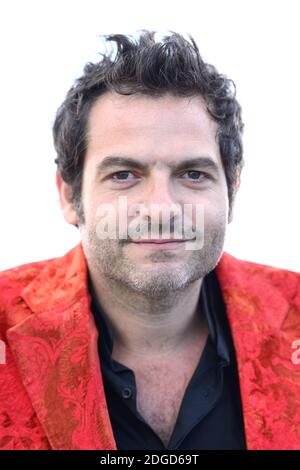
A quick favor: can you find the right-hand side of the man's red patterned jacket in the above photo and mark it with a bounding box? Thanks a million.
[216,253,300,450]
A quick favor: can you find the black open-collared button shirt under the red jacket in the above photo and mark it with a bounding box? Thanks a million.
[89,271,246,450]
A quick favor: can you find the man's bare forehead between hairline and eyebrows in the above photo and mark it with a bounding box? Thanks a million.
[86,93,218,167]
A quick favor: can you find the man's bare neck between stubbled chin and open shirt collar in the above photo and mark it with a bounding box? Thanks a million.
[90,271,207,359]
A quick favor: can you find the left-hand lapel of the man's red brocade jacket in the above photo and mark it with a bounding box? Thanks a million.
[7,245,116,450]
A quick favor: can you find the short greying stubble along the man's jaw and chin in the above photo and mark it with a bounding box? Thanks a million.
[82,220,226,299]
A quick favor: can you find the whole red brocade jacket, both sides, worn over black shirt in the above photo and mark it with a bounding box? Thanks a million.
[0,244,300,450]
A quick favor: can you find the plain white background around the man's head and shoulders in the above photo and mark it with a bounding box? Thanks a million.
[0,0,300,271]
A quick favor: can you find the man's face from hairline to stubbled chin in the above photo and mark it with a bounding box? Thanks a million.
[79,93,228,297]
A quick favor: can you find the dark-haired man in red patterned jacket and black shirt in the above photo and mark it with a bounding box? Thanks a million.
[0,31,300,449]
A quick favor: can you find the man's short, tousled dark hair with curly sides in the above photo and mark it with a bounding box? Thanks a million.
[53,30,244,223]
